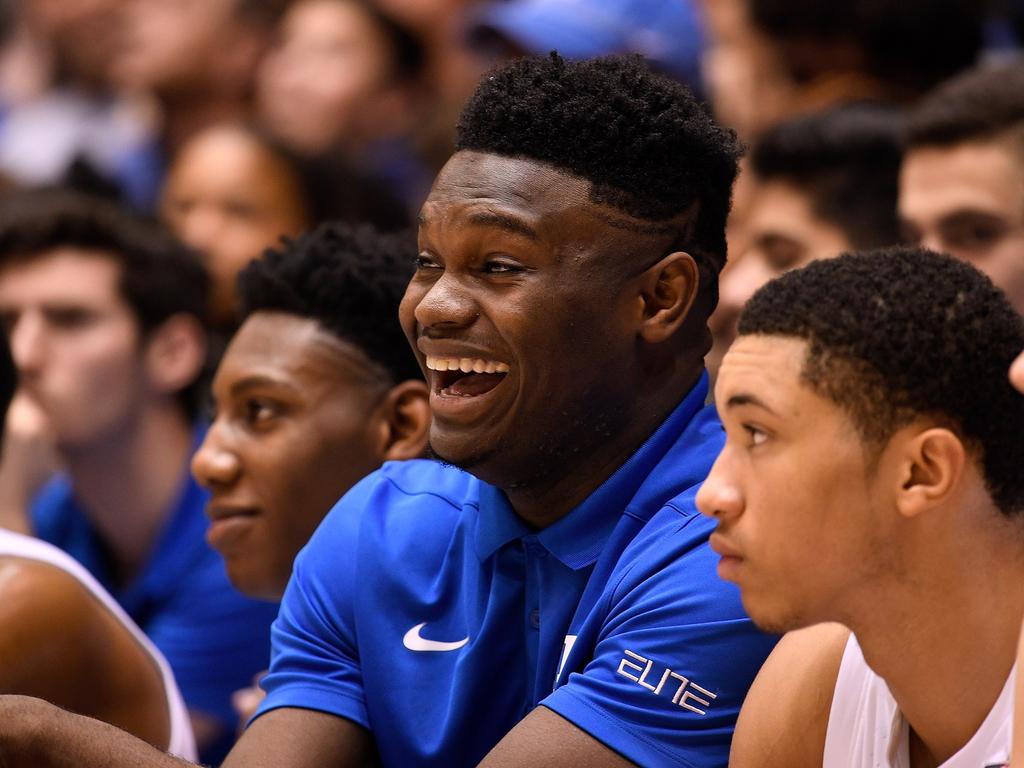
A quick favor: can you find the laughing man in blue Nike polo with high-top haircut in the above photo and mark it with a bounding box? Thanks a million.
[0,56,774,768]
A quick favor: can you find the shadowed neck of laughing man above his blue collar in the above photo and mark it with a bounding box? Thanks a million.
[503,366,703,529]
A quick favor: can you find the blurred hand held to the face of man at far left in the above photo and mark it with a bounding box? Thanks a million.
[0,391,59,534]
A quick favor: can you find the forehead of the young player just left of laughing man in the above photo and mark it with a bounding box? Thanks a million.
[215,311,371,394]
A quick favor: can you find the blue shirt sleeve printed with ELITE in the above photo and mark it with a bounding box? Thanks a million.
[541,507,777,768]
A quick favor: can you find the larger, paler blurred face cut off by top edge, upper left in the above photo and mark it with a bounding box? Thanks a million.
[117,0,263,93]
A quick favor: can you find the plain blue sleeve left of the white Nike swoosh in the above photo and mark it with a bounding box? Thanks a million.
[254,475,376,728]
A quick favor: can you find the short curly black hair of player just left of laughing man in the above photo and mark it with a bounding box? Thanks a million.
[238,222,423,384]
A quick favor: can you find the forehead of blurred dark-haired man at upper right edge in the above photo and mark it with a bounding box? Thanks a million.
[899,140,1024,220]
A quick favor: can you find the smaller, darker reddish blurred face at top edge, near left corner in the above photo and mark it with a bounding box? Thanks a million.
[25,0,130,85]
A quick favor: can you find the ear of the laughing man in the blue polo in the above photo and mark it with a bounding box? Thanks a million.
[638,251,700,344]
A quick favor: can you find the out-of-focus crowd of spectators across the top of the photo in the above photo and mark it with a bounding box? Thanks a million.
[0,0,1024,352]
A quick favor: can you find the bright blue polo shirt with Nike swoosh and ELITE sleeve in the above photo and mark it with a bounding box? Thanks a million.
[257,377,776,766]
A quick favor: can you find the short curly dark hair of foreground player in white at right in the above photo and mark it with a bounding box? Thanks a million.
[739,247,1024,516]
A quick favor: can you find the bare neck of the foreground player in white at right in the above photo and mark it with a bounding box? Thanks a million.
[847,510,1024,768]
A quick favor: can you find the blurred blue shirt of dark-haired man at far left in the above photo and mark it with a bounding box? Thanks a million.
[31,433,278,761]
